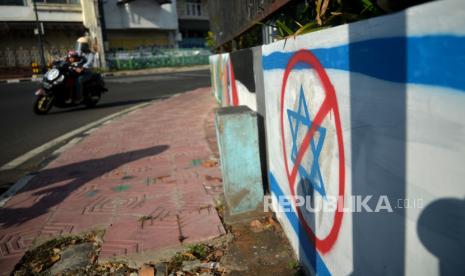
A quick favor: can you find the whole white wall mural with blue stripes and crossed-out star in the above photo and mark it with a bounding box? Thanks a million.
[262,1,465,275]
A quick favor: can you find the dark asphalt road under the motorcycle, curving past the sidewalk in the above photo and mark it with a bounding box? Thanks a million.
[0,70,210,190]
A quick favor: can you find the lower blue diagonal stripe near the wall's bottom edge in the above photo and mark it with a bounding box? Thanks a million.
[269,172,331,276]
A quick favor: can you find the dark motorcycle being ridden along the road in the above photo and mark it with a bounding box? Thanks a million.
[33,61,108,115]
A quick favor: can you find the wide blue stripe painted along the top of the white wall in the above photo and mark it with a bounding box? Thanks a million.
[263,35,465,91]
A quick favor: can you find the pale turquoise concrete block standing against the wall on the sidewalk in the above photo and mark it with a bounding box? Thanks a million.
[215,106,263,215]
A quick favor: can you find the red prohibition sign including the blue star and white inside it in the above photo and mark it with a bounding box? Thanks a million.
[279,50,345,253]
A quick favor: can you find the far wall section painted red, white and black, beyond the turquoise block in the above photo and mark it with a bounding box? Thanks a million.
[210,49,257,111]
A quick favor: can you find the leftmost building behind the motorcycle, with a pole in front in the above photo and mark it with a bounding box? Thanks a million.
[0,0,86,74]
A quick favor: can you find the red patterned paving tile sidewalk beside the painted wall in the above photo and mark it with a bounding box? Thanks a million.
[0,88,225,274]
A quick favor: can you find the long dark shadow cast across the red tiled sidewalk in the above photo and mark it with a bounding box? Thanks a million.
[0,145,169,228]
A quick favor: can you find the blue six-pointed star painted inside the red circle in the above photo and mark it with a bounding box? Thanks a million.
[287,87,326,198]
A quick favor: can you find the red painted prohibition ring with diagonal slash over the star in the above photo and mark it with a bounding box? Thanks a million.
[280,50,345,254]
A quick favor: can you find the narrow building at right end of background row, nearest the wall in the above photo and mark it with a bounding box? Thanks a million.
[177,0,210,48]
